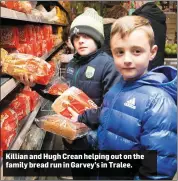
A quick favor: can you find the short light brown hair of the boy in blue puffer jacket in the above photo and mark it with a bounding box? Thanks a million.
[111,16,154,47]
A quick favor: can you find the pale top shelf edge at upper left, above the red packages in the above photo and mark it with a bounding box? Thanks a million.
[0,7,67,26]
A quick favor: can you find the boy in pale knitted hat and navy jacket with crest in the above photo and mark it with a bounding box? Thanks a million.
[63,8,120,179]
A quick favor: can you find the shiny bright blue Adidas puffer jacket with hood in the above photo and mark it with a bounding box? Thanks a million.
[98,66,177,180]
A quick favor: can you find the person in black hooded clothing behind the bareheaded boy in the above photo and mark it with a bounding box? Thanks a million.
[132,1,167,70]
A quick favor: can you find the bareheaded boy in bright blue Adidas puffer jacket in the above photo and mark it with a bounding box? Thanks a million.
[98,16,177,180]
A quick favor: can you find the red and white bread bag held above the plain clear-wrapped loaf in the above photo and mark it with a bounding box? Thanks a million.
[52,87,97,118]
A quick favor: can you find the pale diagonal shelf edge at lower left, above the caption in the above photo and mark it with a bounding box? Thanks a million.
[11,98,43,150]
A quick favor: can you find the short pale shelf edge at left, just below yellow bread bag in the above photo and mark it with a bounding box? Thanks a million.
[0,77,19,101]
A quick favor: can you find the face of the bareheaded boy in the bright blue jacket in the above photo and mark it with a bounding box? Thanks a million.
[111,29,157,80]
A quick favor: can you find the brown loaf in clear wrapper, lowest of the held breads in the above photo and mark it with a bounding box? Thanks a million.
[35,114,89,140]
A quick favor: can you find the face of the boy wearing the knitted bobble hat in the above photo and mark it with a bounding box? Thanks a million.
[73,33,97,55]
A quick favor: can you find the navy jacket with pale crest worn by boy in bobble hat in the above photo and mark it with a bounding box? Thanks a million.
[66,50,120,129]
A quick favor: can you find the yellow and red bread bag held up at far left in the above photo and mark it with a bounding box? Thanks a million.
[2,53,53,85]
